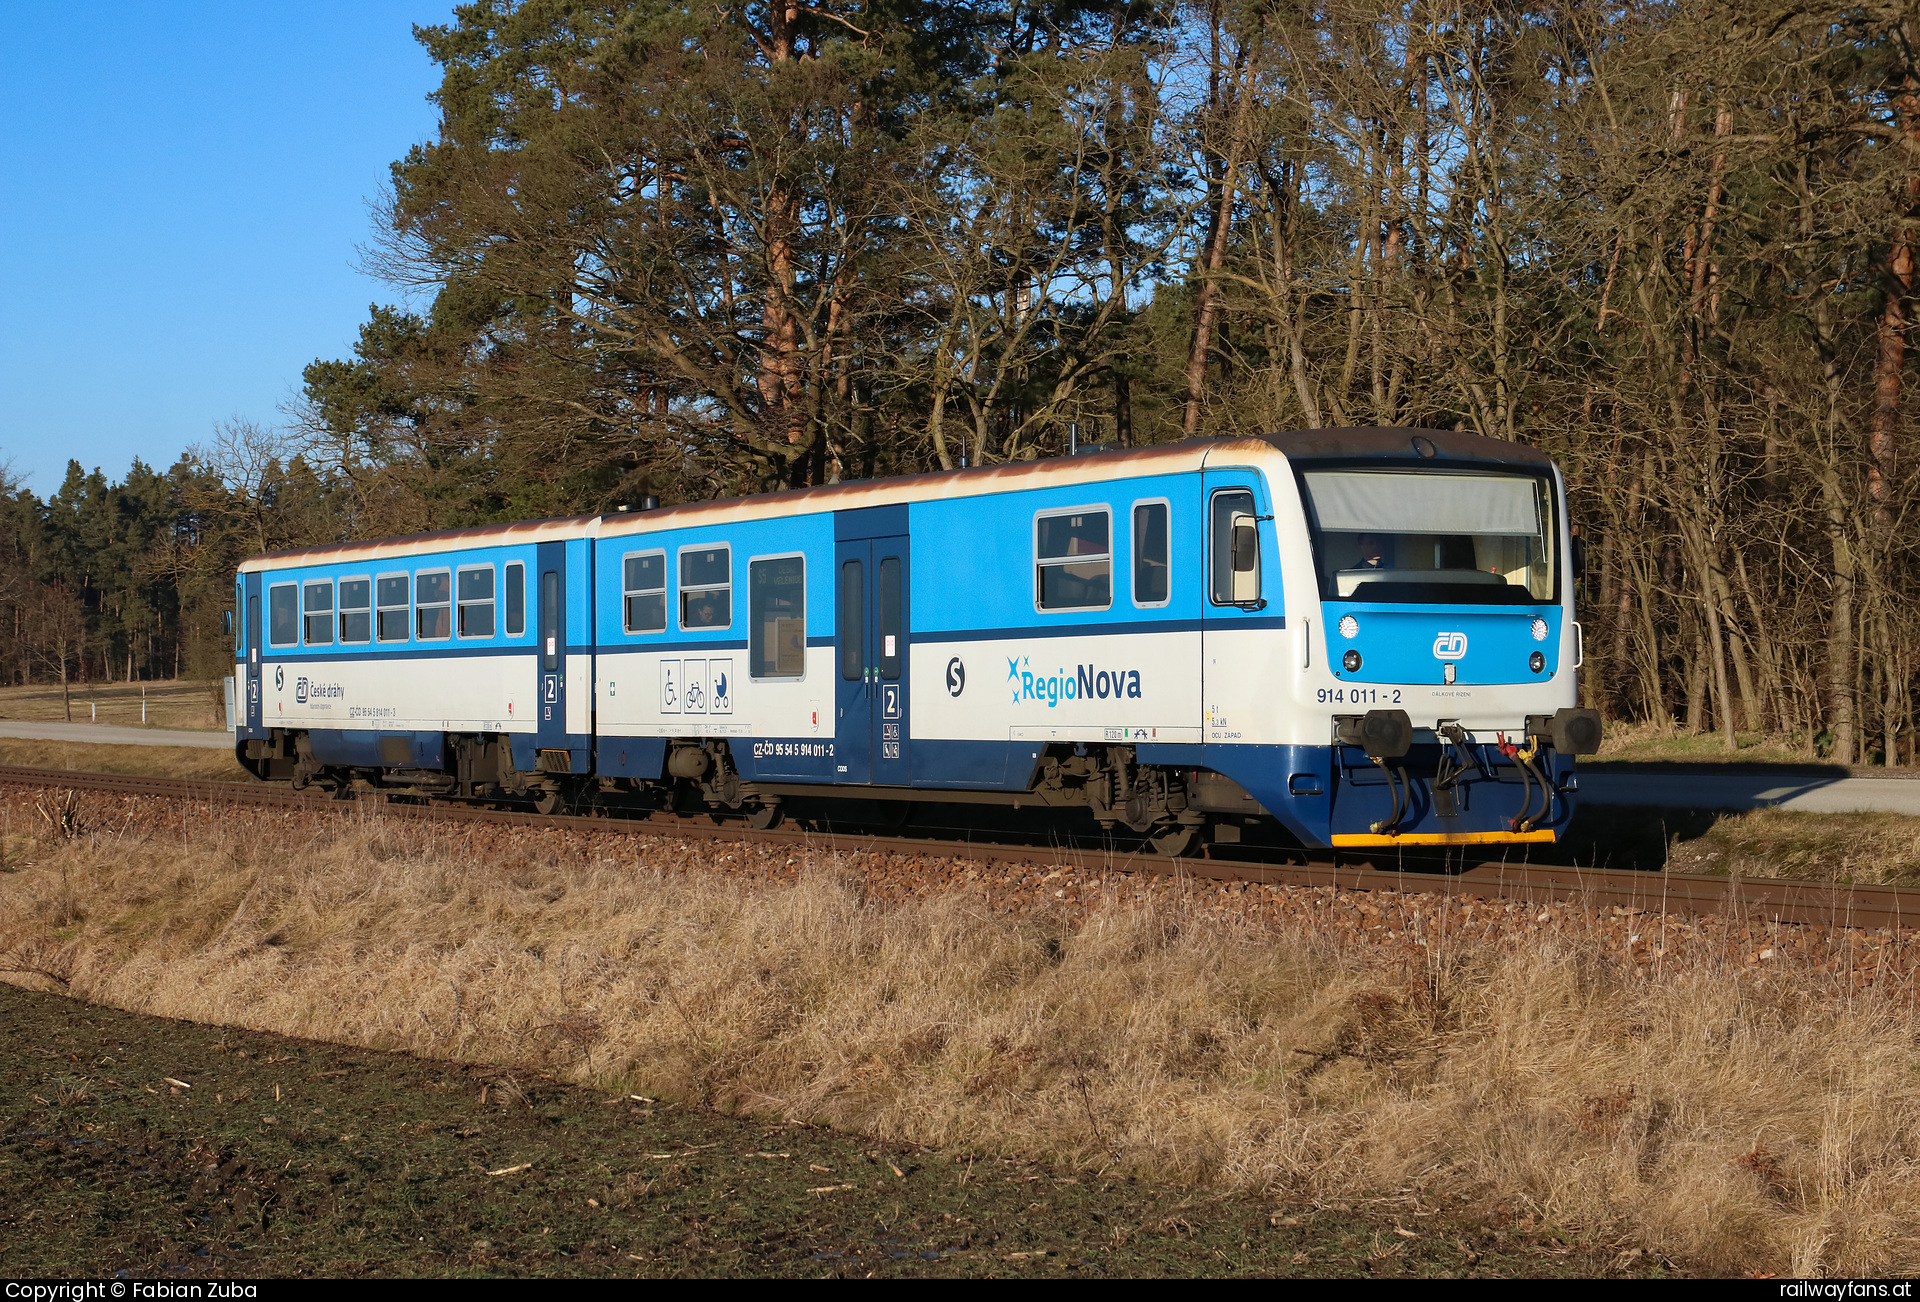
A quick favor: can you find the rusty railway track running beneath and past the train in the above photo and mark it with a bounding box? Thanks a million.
[0,766,1920,929]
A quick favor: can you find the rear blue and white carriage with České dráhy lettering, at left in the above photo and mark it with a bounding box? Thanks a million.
[234,518,593,802]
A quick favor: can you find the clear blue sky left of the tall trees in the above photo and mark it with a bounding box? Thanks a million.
[0,0,451,495]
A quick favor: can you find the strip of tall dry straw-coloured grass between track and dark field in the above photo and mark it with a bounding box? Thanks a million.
[0,803,1920,1275]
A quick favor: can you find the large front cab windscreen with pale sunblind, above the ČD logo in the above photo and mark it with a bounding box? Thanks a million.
[1300,470,1553,605]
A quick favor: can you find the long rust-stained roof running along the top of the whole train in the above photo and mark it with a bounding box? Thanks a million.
[240,426,1551,574]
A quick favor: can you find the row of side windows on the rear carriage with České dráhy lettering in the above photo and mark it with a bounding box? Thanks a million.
[267,561,526,647]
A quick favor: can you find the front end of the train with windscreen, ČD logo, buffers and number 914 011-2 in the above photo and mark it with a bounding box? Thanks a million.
[1275,430,1599,853]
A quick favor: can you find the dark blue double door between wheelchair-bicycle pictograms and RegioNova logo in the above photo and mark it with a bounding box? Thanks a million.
[833,534,912,787]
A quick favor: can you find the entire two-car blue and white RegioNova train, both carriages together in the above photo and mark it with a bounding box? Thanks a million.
[238,430,1597,851]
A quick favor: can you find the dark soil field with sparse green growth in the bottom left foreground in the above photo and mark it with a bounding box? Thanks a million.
[0,985,1590,1279]
